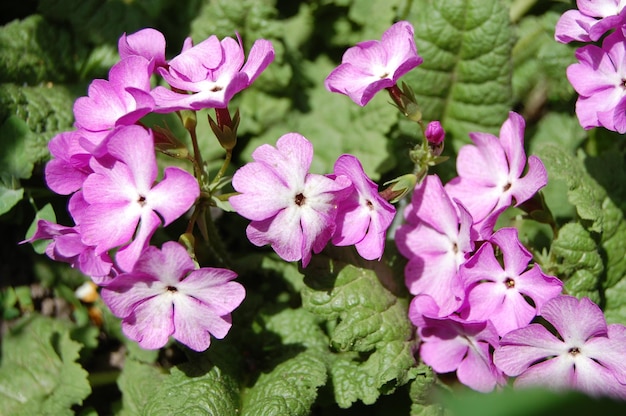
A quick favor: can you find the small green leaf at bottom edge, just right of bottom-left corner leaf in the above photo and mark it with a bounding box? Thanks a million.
[117,357,166,416]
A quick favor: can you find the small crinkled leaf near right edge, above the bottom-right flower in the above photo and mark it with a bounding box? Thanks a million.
[548,223,604,302]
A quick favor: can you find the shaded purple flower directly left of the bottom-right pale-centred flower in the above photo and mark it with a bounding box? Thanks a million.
[409,296,504,392]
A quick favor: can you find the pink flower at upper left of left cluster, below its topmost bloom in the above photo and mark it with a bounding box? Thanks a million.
[74,56,154,136]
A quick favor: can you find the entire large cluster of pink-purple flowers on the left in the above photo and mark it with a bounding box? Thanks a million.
[24,29,274,351]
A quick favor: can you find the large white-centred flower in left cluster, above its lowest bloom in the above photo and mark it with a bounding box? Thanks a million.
[77,126,200,271]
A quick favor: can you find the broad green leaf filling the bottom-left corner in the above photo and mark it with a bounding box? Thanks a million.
[0,315,91,415]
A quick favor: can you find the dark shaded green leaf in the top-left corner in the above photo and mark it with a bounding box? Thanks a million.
[0,15,85,85]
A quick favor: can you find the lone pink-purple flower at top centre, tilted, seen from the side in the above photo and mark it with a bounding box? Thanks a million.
[324,21,423,106]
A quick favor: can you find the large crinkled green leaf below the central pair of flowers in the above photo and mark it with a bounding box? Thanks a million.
[302,252,415,408]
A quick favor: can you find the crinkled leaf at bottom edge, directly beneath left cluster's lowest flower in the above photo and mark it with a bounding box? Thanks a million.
[142,358,240,416]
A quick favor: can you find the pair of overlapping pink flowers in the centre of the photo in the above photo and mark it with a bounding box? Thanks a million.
[230,133,395,267]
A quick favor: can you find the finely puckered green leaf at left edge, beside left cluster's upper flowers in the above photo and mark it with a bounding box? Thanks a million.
[0,84,80,145]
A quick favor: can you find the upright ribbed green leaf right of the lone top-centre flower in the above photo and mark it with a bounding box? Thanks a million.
[404,0,514,141]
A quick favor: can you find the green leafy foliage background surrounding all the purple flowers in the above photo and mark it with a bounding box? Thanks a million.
[0,0,626,415]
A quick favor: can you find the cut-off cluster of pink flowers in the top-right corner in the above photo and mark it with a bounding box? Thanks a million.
[555,0,626,133]
